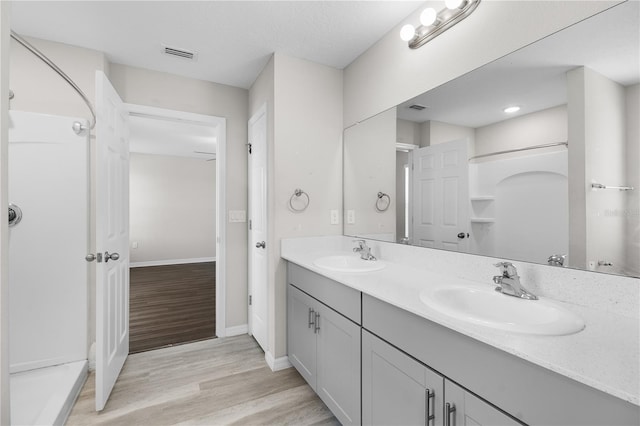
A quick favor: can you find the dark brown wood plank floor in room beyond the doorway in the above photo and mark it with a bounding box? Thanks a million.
[129,262,216,353]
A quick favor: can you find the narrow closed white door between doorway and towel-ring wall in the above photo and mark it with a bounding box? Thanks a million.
[249,106,269,352]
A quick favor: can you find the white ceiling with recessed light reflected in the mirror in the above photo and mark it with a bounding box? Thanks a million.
[398,1,640,128]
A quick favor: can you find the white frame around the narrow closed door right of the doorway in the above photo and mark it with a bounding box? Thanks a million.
[247,102,264,350]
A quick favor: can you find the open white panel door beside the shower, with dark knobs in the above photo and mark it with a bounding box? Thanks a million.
[95,71,129,411]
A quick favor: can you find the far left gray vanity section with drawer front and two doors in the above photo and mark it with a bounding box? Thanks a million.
[287,265,361,425]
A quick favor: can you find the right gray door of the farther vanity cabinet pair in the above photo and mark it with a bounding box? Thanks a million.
[316,303,360,425]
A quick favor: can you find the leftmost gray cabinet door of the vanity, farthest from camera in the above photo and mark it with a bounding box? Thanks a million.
[287,284,319,389]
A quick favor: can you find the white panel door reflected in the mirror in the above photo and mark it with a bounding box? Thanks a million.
[412,139,469,252]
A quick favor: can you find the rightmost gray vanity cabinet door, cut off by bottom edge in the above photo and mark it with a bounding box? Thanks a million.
[444,380,521,426]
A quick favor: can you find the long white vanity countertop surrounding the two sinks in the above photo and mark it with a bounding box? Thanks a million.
[281,244,640,405]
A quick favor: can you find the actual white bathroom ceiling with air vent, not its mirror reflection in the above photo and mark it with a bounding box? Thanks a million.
[11,0,424,88]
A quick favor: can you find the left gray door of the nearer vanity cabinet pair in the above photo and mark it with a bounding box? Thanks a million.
[362,330,444,426]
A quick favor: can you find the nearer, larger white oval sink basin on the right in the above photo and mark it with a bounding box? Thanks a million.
[420,285,584,336]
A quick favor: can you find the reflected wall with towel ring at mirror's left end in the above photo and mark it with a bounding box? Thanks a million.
[344,108,396,241]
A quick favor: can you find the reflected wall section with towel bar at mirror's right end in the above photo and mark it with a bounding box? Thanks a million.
[567,67,638,273]
